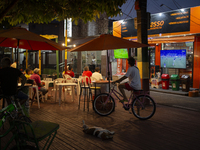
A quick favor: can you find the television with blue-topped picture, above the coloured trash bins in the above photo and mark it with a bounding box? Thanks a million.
[160,49,186,69]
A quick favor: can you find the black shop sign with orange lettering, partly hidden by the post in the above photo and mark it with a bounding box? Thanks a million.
[121,8,190,38]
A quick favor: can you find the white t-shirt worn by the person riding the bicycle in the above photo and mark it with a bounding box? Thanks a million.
[125,66,141,90]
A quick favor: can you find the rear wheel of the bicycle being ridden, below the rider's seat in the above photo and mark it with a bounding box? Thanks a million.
[132,95,156,120]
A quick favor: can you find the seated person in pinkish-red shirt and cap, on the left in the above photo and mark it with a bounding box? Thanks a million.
[29,68,48,95]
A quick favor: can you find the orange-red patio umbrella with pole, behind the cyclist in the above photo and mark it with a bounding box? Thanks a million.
[68,34,148,91]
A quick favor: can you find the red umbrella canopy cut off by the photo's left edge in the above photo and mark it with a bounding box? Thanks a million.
[0,27,66,50]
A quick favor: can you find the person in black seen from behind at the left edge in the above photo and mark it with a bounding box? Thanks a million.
[0,57,29,104]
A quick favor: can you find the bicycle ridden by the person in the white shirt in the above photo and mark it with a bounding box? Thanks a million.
[93,84,156,120]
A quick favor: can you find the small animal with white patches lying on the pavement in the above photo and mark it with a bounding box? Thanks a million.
[83,120,115,140]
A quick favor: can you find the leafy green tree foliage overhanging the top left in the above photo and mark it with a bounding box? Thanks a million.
[0,0,126,25]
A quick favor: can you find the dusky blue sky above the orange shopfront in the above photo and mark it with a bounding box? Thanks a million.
[112,0,200,20]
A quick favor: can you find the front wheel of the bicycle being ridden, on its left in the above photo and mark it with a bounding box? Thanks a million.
[93,93,115,116]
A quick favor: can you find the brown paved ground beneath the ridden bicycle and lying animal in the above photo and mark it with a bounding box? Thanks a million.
[1,93,200,150]
